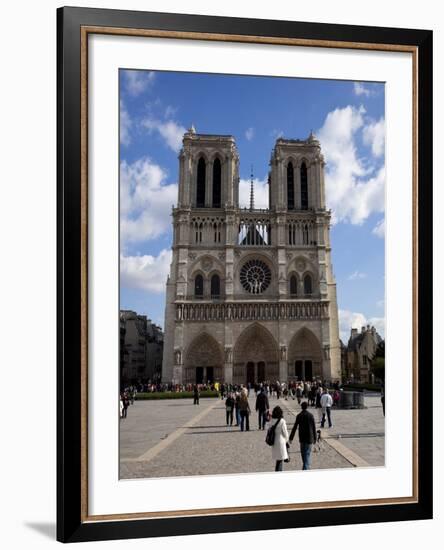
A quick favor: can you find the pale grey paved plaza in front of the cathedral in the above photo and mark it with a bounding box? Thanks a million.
[120,392,385,479]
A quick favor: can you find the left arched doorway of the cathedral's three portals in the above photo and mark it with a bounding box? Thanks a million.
[183,333,223,384]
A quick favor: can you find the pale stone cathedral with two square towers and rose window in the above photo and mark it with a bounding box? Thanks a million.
[162,127,340,384]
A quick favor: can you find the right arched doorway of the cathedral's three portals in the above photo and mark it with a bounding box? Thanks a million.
[288,327,322,380]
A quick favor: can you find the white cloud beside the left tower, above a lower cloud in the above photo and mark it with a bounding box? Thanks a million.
[120,157,177,248]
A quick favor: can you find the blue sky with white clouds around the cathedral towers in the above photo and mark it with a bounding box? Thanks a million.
[119,70,385,340]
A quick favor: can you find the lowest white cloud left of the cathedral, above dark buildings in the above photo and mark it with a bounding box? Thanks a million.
[120,249,172,293]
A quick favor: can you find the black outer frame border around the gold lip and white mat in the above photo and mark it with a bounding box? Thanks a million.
[57,7,433,542]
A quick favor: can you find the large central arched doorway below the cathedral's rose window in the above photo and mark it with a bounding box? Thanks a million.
[233,323,279,384]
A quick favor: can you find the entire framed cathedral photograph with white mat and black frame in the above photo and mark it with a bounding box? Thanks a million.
[57,8,432,542]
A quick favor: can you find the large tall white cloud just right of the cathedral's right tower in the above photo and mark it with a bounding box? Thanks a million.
[318,105,385,225]
